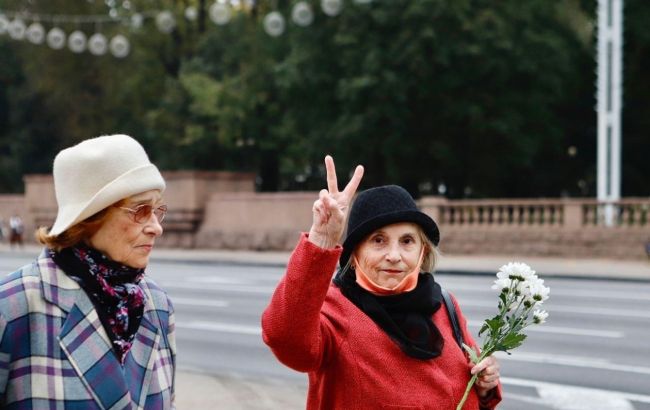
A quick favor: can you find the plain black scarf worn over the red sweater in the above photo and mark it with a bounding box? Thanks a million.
[334,269,444,360]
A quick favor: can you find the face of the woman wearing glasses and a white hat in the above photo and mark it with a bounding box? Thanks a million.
[89,190,163,268]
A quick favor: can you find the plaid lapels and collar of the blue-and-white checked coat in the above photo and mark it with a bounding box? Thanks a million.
[36,250,161,409]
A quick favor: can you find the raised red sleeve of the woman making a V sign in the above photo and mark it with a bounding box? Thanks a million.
[262,233,342,372]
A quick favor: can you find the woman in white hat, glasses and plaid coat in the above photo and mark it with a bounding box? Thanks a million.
[0,135,176,409]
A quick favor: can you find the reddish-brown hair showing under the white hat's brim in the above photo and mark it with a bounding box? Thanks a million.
[35,199,126,252]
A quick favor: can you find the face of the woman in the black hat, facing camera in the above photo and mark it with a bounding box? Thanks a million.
[353,222,423,289]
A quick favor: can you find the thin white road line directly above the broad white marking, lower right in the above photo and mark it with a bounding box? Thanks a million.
[495,352,650,375]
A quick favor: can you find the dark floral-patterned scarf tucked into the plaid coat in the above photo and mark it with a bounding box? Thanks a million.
[49,244,145,364]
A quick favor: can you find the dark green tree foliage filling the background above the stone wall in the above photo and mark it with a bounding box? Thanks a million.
[0,0,650,197]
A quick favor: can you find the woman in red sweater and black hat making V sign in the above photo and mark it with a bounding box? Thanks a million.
[262,156,501,410]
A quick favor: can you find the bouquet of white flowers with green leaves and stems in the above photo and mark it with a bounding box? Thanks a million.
[456,262,550,410]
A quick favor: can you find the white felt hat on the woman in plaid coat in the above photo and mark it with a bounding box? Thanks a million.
[49,135,165,236]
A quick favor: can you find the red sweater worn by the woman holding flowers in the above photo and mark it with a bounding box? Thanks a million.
[262,234,501,410]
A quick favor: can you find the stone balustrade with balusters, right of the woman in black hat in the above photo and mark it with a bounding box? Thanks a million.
[420,197,650,259]
